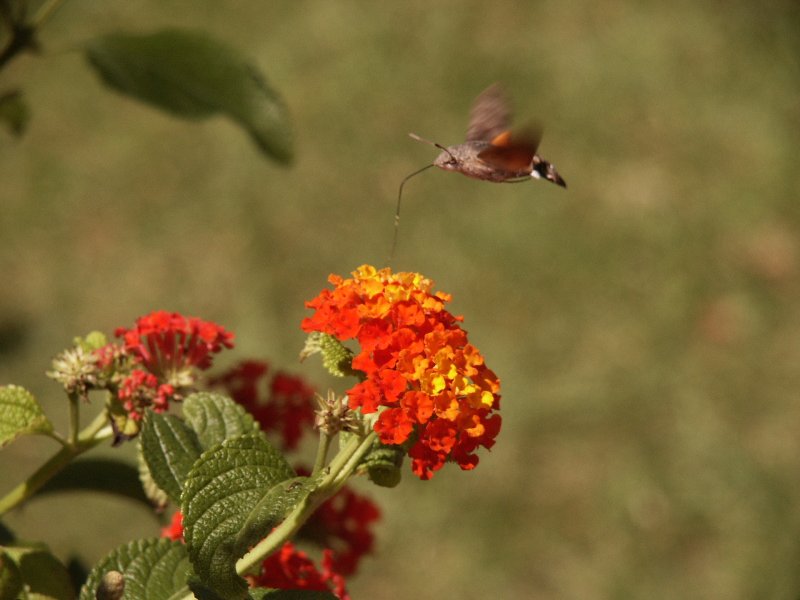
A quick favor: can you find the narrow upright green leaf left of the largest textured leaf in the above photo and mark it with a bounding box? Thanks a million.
[140,410,202,504]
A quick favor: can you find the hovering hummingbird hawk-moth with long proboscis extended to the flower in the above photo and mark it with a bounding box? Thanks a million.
[390,84,567,259]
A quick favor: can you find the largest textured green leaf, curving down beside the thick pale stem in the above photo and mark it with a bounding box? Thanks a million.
[181,433,295,598]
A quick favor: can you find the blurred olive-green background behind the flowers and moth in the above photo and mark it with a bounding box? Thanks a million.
[0,0,800,600]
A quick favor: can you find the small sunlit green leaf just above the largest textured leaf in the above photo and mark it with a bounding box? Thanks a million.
[183,392,261,450]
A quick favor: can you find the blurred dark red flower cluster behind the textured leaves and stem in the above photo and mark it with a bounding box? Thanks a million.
[209,360,314,450]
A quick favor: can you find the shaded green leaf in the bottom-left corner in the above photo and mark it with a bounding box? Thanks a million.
[0,544,75,600]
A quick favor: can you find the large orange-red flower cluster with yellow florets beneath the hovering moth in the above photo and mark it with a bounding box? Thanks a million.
[302,265,500,479]
